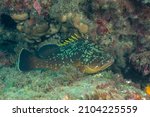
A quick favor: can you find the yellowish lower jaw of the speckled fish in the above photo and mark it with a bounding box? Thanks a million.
[78,59,114,74]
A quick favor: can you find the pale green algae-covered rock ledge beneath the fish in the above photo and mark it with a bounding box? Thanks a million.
[0,67,146,100]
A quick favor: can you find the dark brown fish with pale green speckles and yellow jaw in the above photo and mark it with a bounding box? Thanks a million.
[19,39,113,73]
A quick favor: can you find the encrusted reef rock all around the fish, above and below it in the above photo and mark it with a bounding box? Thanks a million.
[0,0,150,99]
